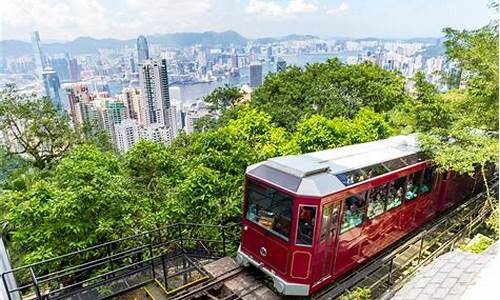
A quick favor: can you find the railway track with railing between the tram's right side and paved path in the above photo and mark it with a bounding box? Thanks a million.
[312,181,498,300]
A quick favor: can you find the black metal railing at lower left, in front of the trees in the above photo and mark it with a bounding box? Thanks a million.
[1,223,240,300]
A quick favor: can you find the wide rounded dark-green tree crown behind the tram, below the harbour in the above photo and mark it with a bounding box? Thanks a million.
[251,59,408,131]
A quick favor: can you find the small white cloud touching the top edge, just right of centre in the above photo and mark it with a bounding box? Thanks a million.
[245,0,318,19]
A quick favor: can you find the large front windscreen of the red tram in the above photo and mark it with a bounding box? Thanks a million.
[246,181,293,240]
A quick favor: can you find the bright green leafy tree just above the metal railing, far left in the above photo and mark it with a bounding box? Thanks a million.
[0,145,136,263]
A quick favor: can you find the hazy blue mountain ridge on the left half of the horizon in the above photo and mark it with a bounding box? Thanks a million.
[0,31,247,56]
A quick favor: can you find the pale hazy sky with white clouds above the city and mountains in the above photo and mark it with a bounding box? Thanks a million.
[0,0,496,41]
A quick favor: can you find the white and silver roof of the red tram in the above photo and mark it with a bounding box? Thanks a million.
[246,134,421,197]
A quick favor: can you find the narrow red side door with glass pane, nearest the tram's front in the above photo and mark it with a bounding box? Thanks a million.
[313,202,340,283]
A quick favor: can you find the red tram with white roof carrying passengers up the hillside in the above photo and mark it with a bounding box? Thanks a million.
[237,135,480,296]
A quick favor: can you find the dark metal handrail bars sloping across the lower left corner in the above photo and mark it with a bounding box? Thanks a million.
[1,223,239,300]
